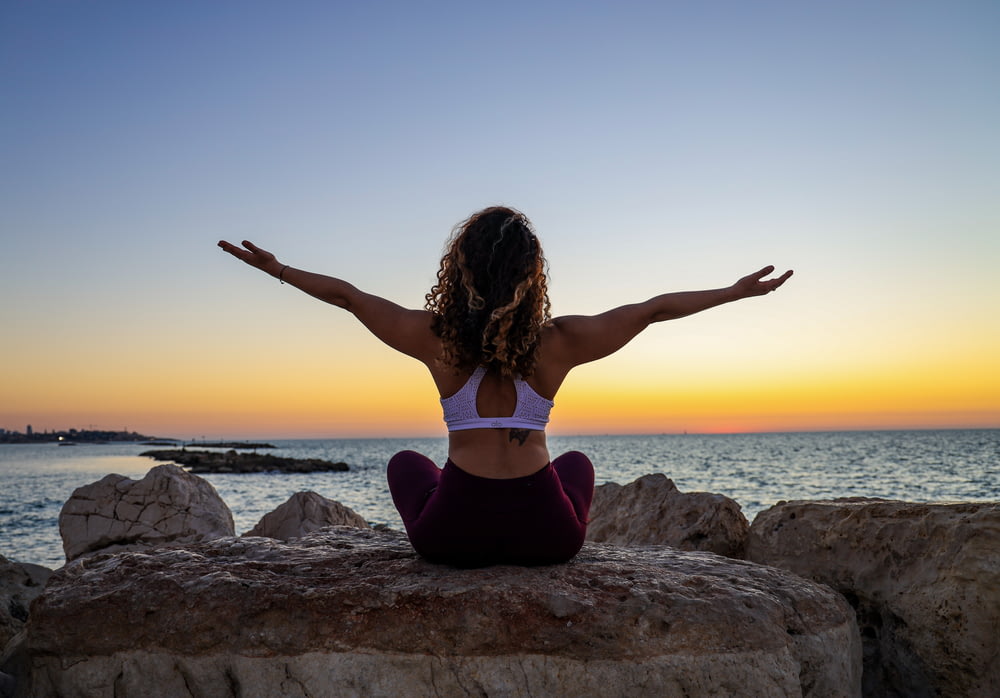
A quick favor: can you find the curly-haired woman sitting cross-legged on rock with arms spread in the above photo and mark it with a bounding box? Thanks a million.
[219,206,792,566]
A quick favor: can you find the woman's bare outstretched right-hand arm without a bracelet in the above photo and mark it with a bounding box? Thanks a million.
[547,266,792,371]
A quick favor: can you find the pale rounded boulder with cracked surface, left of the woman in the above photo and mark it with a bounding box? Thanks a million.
[59,464,235,561]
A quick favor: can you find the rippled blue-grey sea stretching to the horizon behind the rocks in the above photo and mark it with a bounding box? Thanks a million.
[0,429,1000,569]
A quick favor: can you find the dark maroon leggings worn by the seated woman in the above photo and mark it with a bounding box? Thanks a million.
[388,451,594,567]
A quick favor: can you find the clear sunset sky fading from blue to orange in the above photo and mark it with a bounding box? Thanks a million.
[0,0,1000,438]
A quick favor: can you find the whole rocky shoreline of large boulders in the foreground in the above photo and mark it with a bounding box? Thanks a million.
[0,464,1000,698]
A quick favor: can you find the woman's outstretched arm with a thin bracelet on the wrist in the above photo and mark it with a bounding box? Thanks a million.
[219,240,439,363]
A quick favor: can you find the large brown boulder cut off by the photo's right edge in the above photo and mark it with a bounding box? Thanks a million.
[747,498,1000,696]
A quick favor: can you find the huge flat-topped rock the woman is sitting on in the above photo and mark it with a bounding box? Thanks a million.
[22,528,861,698]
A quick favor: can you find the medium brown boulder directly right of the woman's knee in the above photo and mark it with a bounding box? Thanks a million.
[587,473,750,559]
